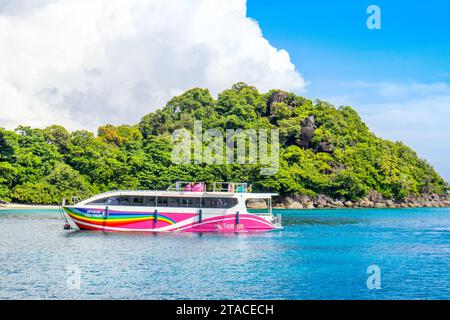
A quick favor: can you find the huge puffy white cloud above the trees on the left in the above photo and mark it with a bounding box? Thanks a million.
[0,0,305,130]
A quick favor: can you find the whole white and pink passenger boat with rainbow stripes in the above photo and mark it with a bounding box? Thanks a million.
[62,181,281,233]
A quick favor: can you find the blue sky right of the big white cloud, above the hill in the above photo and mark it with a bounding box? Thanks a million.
[247,0,450,181]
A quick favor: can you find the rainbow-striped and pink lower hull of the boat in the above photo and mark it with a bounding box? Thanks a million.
[64,207,280,233]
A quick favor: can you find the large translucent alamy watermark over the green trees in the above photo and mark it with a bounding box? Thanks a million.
[172,121,280,176]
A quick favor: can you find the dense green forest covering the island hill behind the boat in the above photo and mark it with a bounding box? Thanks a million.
[0,83,448,204]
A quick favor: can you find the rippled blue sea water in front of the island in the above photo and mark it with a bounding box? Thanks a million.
[0,209,450,299]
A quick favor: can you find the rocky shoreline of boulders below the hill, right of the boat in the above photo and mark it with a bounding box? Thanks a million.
[273,191,450,209]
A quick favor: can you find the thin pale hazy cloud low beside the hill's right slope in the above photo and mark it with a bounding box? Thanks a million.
[326,81,450,181]
